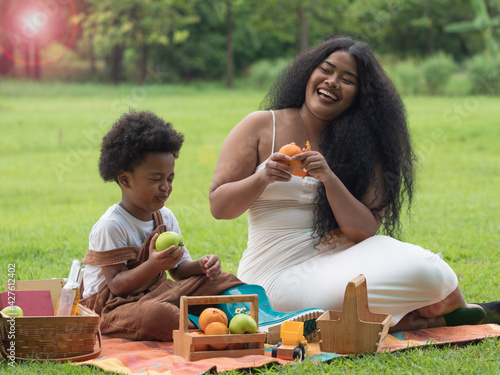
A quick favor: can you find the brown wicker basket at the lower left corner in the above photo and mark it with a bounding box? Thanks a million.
[0,280,102,361]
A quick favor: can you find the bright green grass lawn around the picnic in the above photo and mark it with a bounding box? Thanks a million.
[0,81,500,374]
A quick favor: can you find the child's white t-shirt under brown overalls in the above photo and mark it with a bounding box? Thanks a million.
[82,204,191,298]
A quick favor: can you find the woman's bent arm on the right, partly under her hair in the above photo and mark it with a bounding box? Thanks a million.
[292,151,384,243]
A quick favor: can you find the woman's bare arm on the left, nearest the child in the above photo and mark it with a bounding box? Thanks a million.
[209,112,291,219]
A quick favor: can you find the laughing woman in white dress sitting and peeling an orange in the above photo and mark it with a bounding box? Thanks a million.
[210,33,485,331]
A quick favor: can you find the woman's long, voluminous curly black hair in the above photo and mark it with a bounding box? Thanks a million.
[261,36,415,239]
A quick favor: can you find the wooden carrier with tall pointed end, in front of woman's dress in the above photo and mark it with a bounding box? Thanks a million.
[316,275,391,354]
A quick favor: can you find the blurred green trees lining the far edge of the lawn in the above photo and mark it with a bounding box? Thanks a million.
[0,0,500,88]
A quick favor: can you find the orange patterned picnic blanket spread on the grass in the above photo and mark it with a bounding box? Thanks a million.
[73,324,500,375]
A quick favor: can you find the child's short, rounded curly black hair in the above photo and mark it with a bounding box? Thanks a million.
[99,110,184,183]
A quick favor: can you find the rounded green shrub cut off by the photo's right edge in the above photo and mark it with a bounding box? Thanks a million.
[465,54,500,95]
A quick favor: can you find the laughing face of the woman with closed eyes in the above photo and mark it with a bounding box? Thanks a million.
[304,51,359,121]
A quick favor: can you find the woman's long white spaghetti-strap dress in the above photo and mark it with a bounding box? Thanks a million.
[238,113,458,325]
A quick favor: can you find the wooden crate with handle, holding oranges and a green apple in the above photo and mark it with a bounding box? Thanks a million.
[173,294,266,361]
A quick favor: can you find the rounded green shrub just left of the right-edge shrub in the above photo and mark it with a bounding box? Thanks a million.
[422,53,455,95]
